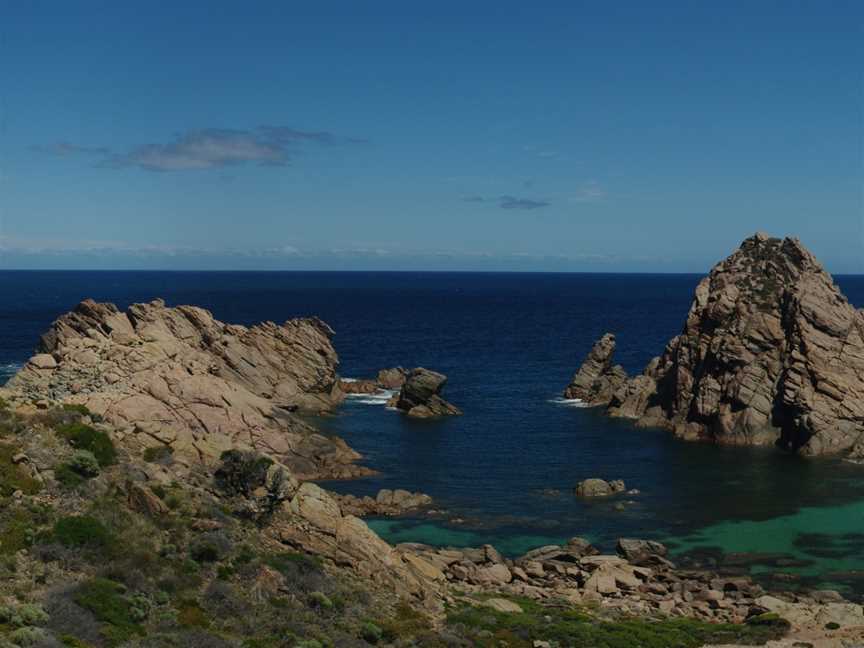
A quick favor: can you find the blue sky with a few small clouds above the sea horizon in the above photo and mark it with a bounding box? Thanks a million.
[0,0,864,272]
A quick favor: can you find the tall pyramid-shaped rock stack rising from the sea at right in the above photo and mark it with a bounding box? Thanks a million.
[577,234,864,457]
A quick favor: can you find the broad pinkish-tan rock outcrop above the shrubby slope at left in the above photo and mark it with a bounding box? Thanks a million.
[6,300,368,478]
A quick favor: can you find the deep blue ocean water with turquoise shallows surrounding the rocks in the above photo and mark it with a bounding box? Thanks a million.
[0,272,864,592]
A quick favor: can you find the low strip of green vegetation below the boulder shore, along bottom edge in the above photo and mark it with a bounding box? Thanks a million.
[447,599,788,648]
